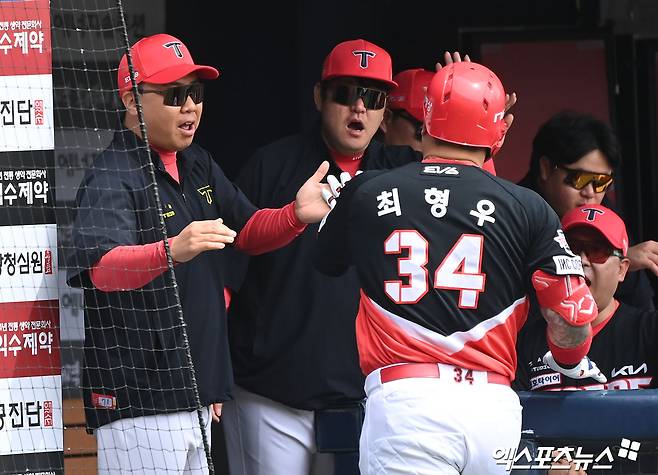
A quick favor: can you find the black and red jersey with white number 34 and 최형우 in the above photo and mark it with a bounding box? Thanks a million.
[316,159,582,379]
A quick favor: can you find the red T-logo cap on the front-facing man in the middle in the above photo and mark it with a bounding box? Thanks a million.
[322,39,398,88]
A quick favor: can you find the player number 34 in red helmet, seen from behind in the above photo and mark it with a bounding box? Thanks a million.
[316,62,605,475]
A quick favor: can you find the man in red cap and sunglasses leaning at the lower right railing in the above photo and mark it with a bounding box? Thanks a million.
[514,204,658,391]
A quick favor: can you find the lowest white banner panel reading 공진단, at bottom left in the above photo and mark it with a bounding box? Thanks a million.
[0,376,64,455]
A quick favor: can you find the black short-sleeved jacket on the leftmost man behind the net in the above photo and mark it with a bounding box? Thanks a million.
[68,130,256,428]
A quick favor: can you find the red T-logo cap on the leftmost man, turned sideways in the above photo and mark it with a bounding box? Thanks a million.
[117,33,219,93]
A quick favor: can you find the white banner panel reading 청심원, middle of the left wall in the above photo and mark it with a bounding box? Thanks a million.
[0,224,59,303]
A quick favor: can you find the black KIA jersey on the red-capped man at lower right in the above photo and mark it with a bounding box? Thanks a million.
[514,303,658,391]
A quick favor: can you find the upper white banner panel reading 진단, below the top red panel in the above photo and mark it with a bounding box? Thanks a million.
[0,74,54,152]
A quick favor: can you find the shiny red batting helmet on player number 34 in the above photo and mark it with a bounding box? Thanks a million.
[425,61,507,156]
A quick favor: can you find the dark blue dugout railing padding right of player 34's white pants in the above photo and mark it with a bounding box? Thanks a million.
[512,389,658,475]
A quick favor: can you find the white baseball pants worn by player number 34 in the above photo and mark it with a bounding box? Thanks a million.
[359,365,521,475]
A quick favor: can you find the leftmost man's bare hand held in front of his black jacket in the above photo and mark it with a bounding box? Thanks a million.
[170,218,237,262]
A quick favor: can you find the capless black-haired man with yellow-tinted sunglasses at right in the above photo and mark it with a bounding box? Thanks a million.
[519,111,658,309]
